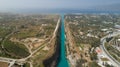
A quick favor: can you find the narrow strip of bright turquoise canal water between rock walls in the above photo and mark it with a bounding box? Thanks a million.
[58,14,69,67]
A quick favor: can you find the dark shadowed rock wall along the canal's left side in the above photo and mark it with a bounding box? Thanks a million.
[43,17,61,67]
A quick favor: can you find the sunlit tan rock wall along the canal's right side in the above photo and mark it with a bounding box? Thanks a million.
[65,21,80,67]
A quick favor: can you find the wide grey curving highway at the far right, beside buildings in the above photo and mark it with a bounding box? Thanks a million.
[100,32,120,67]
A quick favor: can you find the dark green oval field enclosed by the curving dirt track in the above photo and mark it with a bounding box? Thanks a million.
[3,40,29,58]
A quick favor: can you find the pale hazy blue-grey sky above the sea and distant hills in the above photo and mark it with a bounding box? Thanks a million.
[0,0,120,10]
